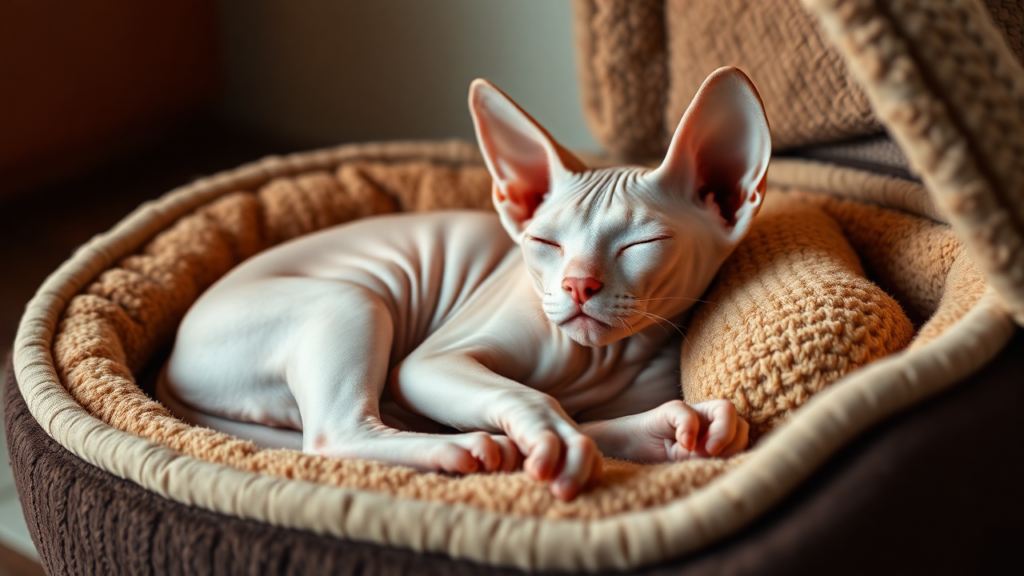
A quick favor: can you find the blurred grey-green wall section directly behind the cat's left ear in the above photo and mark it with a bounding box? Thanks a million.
[219,0,599,151]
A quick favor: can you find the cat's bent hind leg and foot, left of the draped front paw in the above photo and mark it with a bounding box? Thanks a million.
[286,281,519,474]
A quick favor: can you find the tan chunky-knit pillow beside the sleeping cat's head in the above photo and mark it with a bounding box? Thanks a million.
[681,191,913,438]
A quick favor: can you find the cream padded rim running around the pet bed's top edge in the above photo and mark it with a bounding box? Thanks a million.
[14,142,1014,571]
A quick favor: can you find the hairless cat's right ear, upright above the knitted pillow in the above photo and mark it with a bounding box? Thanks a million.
[651,67,771,242]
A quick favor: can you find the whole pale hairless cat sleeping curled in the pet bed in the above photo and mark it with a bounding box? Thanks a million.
[164,69,770,498]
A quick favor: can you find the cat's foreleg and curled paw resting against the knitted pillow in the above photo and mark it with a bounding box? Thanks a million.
[585,400,750,462]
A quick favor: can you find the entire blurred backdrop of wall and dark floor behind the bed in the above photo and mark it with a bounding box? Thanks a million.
[0,0,598,576]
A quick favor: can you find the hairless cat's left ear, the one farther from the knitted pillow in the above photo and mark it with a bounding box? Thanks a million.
[469,79,587,242]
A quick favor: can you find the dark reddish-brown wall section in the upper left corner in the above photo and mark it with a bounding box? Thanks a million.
[0,0,220,198]
